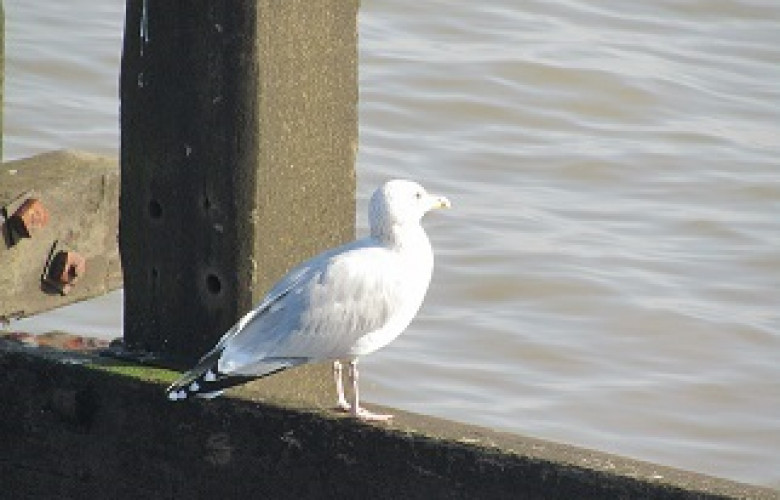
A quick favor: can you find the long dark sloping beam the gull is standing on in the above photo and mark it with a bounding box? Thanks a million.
[0,341,780,500]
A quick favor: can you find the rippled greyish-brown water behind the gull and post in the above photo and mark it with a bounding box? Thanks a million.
[5,0,780,487]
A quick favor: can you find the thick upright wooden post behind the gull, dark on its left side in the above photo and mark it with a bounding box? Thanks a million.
[119,0,358,364]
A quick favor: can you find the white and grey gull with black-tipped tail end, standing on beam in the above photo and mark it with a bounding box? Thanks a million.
[166,180,450,420]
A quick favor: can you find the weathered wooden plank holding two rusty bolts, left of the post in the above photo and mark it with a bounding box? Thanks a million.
[0,151,122,318]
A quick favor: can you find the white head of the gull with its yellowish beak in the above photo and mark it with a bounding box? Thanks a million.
[368,179,450,236]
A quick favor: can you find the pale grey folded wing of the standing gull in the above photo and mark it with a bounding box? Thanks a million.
[219,247,403,374]
